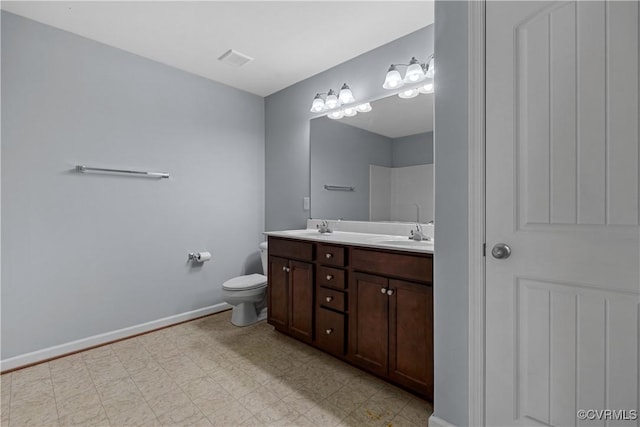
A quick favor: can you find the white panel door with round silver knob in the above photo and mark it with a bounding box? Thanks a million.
[485,1,640,426]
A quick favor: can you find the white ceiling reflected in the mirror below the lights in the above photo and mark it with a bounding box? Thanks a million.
[339,93,433,138]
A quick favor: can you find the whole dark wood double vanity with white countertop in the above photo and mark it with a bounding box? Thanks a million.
[265,222,433,400]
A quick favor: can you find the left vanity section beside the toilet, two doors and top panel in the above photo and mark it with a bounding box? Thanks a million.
[267,238,314,342]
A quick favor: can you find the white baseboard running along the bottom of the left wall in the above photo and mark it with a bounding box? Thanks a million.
[0,302,232,372]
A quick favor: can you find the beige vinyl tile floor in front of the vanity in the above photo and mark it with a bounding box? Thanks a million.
[0,311,432,427]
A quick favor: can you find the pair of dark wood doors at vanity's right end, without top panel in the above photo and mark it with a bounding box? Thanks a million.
[349,273,433,399]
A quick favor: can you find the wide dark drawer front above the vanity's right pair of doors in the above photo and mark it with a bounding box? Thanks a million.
[351,248,433,283]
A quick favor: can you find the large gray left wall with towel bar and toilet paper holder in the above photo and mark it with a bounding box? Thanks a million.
[1,12,264,359]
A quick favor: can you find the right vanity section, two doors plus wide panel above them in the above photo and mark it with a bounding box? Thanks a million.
[348,248,433,399]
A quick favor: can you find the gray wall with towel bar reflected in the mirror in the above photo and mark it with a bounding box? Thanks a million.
[310,117,392,221]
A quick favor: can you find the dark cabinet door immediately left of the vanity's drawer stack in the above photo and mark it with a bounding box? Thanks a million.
[289,261,313,341]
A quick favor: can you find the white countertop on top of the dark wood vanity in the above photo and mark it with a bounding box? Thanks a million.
[264,228,434,254]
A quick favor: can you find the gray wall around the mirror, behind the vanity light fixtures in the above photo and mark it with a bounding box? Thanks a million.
[265,26,433,230]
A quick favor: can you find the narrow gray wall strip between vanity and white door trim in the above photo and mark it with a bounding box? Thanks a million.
[433,1,469,426]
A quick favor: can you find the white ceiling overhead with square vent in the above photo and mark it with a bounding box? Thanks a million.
[1,0,433,96]
